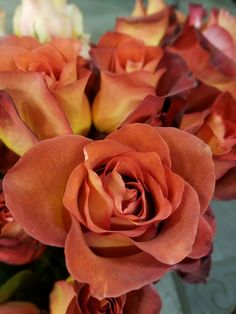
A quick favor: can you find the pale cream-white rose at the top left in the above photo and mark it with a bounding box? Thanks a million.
[13,0,83,43]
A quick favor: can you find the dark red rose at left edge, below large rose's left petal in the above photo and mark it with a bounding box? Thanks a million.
[0,181,44,265]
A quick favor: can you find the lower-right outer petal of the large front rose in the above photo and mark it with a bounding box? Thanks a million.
[133,184,199,265]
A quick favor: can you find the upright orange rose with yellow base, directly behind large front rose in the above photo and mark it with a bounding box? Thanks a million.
[91,32,165,133]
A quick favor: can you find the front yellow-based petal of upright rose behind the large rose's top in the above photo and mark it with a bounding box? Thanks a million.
[92,71,162,133]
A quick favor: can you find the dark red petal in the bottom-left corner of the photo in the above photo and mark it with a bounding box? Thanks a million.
[0,301,41,314]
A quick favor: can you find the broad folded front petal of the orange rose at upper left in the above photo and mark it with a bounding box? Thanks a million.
[0,72,72,139]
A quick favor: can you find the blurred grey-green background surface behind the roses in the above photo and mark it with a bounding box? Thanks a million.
[0,0,236,314]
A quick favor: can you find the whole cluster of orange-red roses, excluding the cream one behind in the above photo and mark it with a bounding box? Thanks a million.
[0,0,236,314]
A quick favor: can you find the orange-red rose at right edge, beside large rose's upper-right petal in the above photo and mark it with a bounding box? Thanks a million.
[180,92,236,199]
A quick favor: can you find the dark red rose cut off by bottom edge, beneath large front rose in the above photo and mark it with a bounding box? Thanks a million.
[66,282,161,314]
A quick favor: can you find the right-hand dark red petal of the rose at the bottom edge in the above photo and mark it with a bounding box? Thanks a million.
[124,285,161,314]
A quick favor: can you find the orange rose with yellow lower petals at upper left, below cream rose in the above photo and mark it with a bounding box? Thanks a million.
[0,36,91,155]
